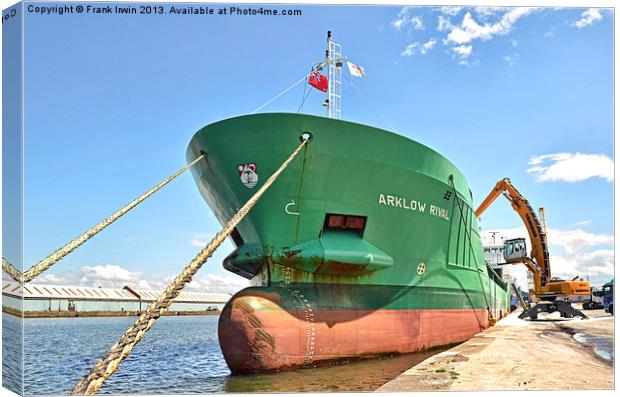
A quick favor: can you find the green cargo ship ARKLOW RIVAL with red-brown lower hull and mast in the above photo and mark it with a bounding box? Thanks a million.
[187,31,510,374]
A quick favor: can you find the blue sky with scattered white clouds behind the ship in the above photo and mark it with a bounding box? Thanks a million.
[3,3,613,288]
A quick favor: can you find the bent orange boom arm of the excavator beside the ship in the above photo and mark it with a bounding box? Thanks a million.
[476,178,551,295]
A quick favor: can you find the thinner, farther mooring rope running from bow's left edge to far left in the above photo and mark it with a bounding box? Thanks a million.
[18,154,205,283]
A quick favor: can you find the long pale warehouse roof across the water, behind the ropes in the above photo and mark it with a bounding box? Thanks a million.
[2,281,231,303]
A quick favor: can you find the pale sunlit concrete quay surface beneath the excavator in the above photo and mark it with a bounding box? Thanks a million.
[376,310,614,392]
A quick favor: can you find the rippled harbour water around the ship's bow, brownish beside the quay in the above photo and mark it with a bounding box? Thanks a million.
[2,313,437,395]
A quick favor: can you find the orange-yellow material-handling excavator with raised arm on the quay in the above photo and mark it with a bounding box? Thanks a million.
[476,178,590,319]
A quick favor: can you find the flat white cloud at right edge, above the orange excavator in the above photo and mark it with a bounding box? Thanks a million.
[527,153,614,182]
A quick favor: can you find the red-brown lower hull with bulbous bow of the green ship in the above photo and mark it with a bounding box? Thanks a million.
[218,295,489,374]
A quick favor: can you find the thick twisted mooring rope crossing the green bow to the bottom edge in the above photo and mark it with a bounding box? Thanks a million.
[71,138,308,395]
